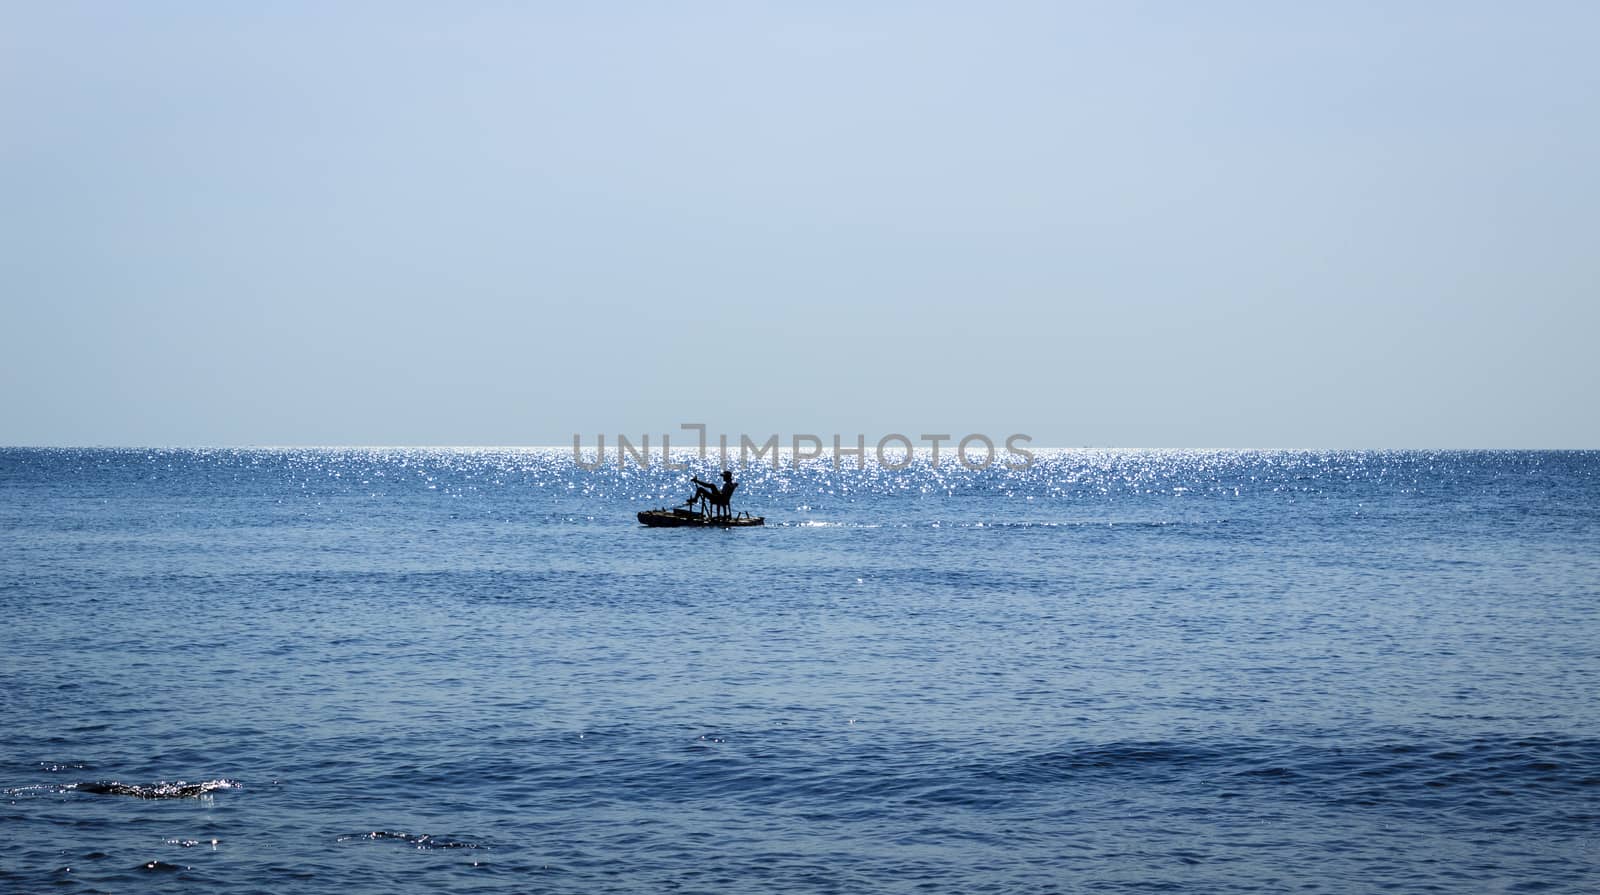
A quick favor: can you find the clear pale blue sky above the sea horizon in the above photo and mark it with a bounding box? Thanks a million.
[0,0,1600,448]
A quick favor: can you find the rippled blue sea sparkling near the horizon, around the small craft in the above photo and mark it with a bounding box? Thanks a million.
[0,450,1600,895]
